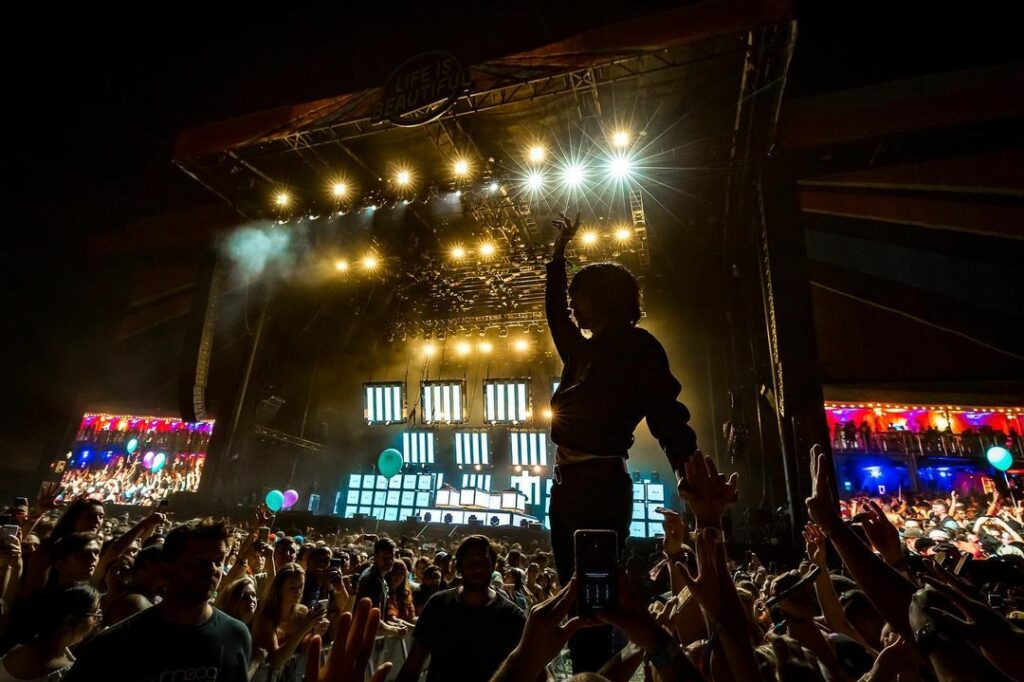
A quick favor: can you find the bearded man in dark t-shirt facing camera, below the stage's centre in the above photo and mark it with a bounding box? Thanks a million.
[397,536,526,682]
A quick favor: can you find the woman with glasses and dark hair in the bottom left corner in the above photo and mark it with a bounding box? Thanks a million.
[0,583,103,682]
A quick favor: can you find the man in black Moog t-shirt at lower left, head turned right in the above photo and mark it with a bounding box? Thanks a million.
[66,519,252,682]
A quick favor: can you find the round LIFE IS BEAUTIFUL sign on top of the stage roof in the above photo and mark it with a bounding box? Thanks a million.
[373,52,466,126]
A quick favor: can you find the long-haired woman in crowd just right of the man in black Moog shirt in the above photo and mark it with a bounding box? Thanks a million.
[252,563,330,670]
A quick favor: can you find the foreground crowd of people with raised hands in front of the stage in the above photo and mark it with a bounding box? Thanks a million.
[0,446,1024,682]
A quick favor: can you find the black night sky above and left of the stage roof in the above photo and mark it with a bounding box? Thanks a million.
[0,0,1020,430]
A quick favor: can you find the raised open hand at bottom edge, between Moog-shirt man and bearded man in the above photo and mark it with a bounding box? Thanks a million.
[303,599,391,682]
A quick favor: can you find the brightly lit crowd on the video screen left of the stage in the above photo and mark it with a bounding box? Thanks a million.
[54,457,206,507]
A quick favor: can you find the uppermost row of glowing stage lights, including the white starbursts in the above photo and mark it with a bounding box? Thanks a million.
[272,130,634,210]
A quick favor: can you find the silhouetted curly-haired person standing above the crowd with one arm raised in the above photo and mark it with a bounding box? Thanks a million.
[545,214,696,673]
